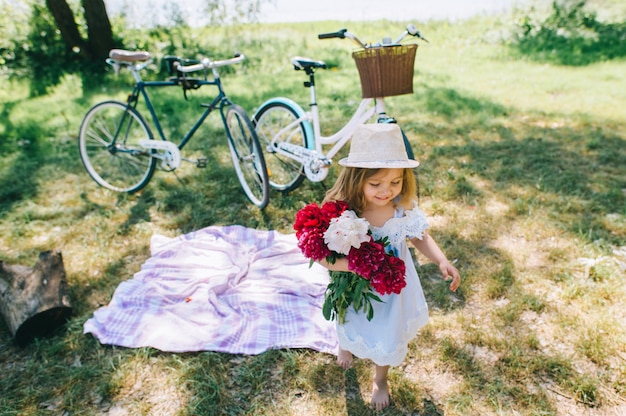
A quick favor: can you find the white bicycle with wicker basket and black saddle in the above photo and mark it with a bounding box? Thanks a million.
[252,24,428,192]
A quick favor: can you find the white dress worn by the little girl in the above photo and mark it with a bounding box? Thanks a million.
[337,204,428,366]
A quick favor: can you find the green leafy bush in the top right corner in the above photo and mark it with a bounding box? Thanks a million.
[513,0,626,65]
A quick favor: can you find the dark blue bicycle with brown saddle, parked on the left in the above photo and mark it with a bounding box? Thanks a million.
[78,49,269,209]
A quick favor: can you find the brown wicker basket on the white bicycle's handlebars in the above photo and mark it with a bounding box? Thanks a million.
[352,43,417,98]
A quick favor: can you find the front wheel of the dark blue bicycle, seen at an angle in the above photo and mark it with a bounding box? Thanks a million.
[225,104,270,209]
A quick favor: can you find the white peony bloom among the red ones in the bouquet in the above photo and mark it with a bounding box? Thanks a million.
[324,210,370,256]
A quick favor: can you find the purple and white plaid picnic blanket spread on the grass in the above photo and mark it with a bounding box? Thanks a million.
[83,225,337,354]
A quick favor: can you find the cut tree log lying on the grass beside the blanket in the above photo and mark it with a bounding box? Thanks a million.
[0,251,72,346]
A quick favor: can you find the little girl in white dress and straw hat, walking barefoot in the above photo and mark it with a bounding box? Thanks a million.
[320,124,461,410]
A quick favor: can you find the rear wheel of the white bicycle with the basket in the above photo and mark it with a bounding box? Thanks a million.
[252,101,309,192]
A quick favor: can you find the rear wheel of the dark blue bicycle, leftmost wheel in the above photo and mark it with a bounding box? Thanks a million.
[78,101,156,193]
